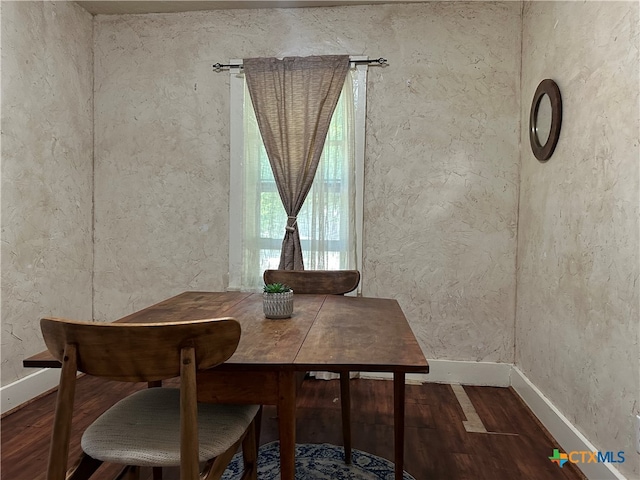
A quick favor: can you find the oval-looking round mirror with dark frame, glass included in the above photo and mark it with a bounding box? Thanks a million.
[529,79,562,162]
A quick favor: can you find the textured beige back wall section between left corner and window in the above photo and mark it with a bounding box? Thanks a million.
[94,9,229,320]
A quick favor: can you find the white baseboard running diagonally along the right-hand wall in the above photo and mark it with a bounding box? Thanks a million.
[511,366,625,480]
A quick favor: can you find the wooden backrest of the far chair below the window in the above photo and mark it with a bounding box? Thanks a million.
[263,270,360,295]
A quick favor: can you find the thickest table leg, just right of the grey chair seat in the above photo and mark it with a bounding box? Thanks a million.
[278,372,296,480]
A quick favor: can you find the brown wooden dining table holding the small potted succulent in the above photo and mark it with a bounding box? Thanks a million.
[23,292,429,480]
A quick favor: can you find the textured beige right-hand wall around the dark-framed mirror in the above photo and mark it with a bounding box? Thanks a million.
[516,2,640,478]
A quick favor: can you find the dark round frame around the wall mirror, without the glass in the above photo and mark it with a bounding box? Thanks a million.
[529,78,562,162]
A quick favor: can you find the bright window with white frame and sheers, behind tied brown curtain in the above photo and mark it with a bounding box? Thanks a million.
[229,58,367,291]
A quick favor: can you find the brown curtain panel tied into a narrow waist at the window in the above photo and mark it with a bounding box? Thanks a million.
[243,55,349,270]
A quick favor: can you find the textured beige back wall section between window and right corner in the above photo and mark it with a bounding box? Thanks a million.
[357,2,521,362]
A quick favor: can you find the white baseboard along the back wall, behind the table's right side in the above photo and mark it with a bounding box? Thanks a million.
[360,360,512,387]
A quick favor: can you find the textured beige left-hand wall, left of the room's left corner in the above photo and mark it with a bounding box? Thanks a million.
[0,2,93,385]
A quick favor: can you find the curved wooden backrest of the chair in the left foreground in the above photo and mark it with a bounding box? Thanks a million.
[40,317,240,382]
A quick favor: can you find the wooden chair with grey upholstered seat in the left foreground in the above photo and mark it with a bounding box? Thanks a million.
[40,318,259,480]
